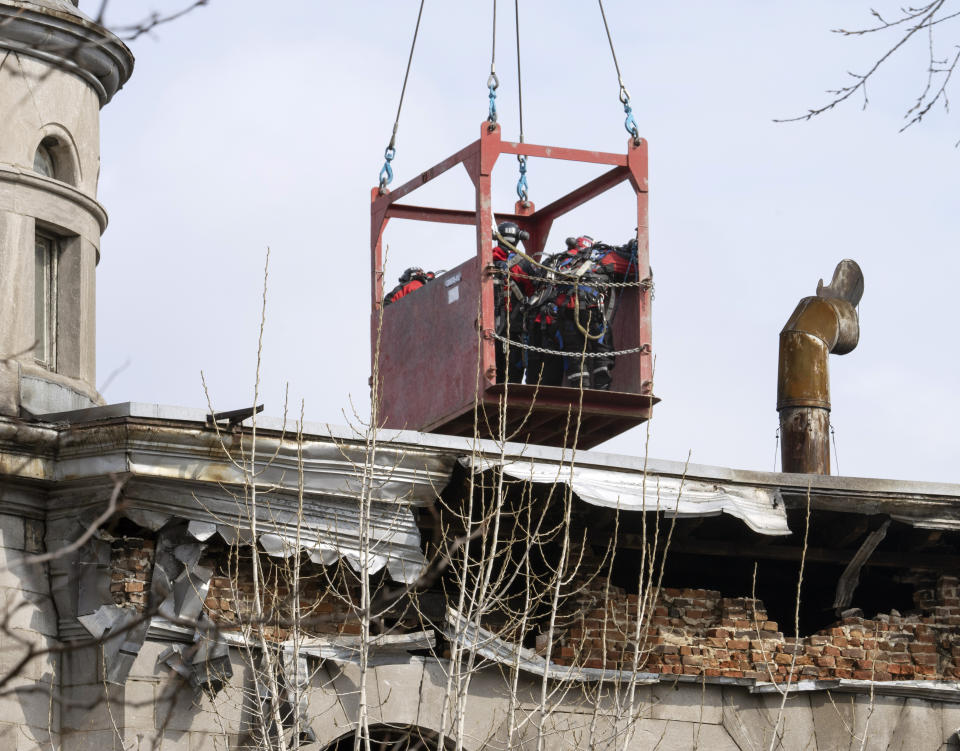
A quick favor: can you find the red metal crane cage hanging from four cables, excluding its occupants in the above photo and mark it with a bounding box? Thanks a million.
[370,122,658,448]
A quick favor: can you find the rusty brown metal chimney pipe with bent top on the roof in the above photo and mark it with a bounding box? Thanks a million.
[777,259,863,475]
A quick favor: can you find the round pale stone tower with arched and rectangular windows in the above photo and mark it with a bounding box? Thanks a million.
[0,0,133,415]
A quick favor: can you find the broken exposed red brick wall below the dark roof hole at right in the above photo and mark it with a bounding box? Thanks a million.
[554,576,960,681]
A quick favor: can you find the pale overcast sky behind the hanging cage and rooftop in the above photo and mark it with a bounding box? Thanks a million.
[80,0,960,482]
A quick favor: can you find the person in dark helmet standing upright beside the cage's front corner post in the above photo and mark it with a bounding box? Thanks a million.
[493,222,537,383]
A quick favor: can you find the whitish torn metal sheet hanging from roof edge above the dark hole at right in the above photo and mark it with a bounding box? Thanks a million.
[460,457,790,535]
